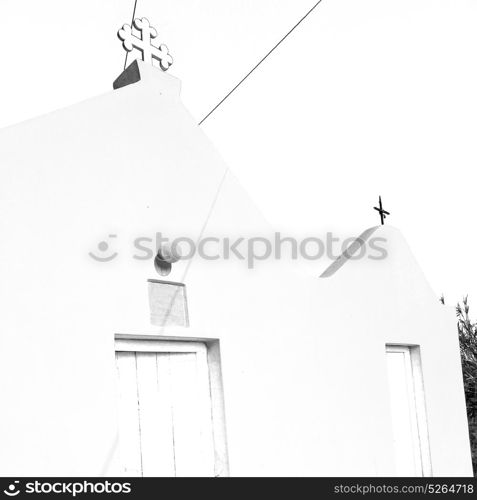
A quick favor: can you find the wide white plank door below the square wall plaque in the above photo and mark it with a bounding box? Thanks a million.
[116,341,214,476]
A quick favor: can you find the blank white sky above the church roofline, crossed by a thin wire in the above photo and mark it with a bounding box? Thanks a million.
[0,0,477,313]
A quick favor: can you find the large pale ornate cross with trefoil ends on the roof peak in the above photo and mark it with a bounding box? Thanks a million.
[118,17,172,71]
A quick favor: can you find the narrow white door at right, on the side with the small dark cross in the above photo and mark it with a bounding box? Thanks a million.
[386,345,431,477]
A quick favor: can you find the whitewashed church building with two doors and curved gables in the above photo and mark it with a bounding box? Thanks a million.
[0,19,472,476]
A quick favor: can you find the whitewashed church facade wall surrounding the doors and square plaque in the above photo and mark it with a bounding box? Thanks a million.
[0,63,471,476]
